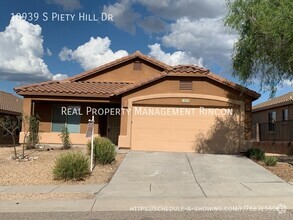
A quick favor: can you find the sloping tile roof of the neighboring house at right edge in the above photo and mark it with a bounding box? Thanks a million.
[252,92,293,111]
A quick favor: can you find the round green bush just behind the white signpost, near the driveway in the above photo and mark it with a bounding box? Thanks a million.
[87,137,116,164]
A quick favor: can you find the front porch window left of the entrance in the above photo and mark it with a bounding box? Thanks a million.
[52,105,80,133]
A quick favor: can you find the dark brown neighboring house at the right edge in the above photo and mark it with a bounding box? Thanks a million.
[252,92,293,154]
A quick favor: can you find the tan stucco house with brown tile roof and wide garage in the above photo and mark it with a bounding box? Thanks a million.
[15,52,260,153]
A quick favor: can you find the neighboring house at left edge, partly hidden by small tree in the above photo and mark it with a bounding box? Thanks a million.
[0,91,22,145]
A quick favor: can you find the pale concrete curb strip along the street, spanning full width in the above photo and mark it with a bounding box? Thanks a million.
[0,197,293,213]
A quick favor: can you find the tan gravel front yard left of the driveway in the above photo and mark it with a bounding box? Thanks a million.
[0,147,125,186]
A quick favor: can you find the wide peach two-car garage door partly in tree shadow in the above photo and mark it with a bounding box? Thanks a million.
[131,106,239,152]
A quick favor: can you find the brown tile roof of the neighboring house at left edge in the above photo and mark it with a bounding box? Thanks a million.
[0,91,22,114]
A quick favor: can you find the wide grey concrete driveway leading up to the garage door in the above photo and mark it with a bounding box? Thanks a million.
[98,151,293,198]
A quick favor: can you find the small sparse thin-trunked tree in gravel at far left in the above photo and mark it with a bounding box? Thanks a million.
[0,115,21,158]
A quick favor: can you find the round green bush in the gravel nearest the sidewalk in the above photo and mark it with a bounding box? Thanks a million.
[53,152,90,180]
